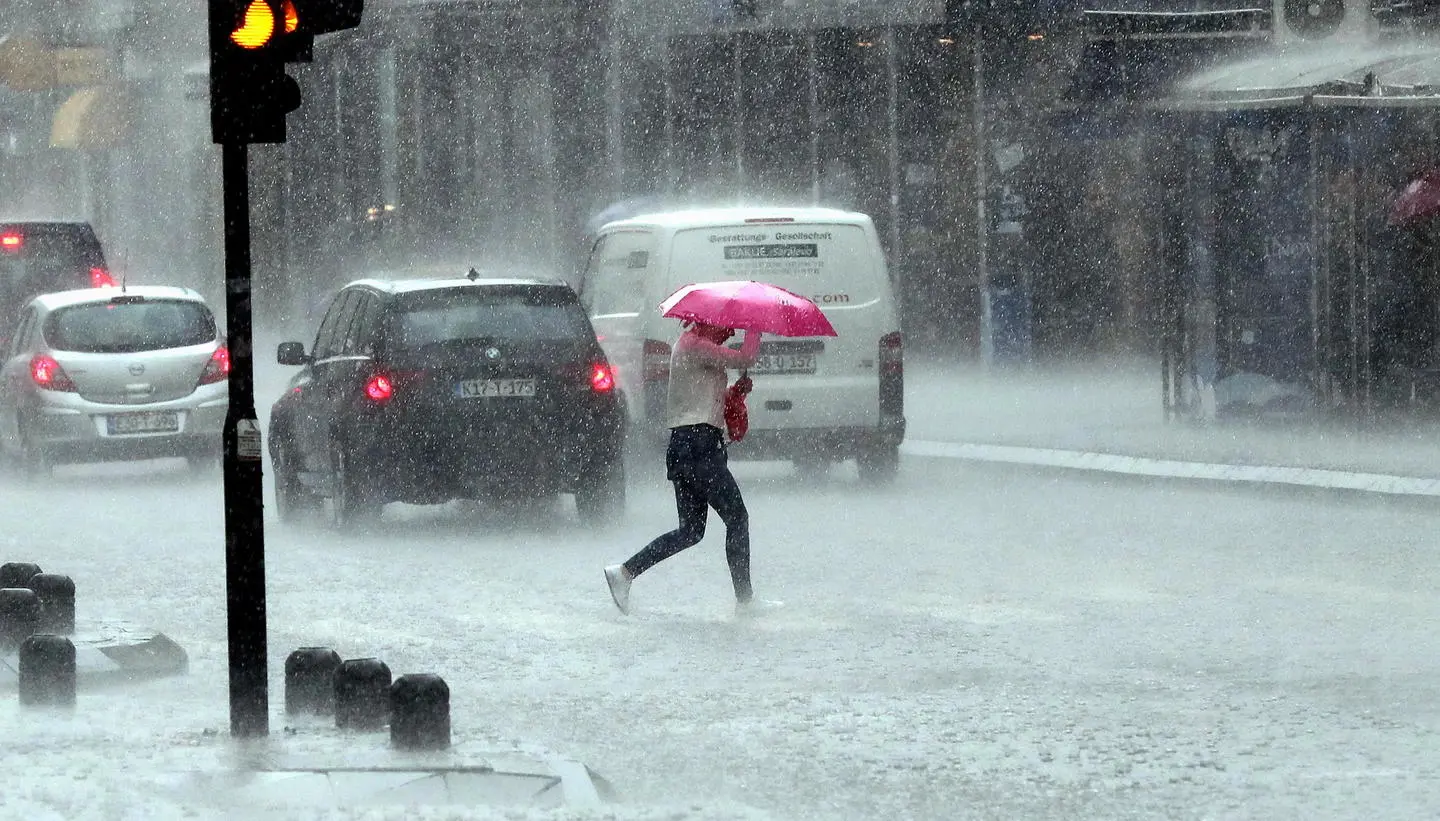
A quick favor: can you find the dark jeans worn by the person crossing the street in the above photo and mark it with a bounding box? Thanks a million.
[625,425,752,602]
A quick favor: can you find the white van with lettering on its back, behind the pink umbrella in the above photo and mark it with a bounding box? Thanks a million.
[579,207,906,480]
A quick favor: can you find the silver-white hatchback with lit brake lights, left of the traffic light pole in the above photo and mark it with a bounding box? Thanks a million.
[0,285,230,475]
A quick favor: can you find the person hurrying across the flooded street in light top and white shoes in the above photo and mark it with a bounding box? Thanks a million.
[605,323,760,614]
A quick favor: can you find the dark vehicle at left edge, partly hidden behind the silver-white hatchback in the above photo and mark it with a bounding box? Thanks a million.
[0,222,115,349]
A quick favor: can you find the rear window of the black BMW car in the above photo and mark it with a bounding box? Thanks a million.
[386,287,595,350]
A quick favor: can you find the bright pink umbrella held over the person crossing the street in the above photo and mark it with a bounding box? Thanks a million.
[660,279,838,337]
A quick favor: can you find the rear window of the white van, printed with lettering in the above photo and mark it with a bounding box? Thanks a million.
[671,223,886,305]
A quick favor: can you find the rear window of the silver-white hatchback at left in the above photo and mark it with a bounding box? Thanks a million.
[45,300,215,353]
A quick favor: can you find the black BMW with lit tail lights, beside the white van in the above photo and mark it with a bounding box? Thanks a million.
[269,271,625,527]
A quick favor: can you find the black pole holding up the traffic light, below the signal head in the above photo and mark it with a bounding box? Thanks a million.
[220,141,269,737]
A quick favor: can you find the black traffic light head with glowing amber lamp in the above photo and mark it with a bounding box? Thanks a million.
[210,0,364,143]
